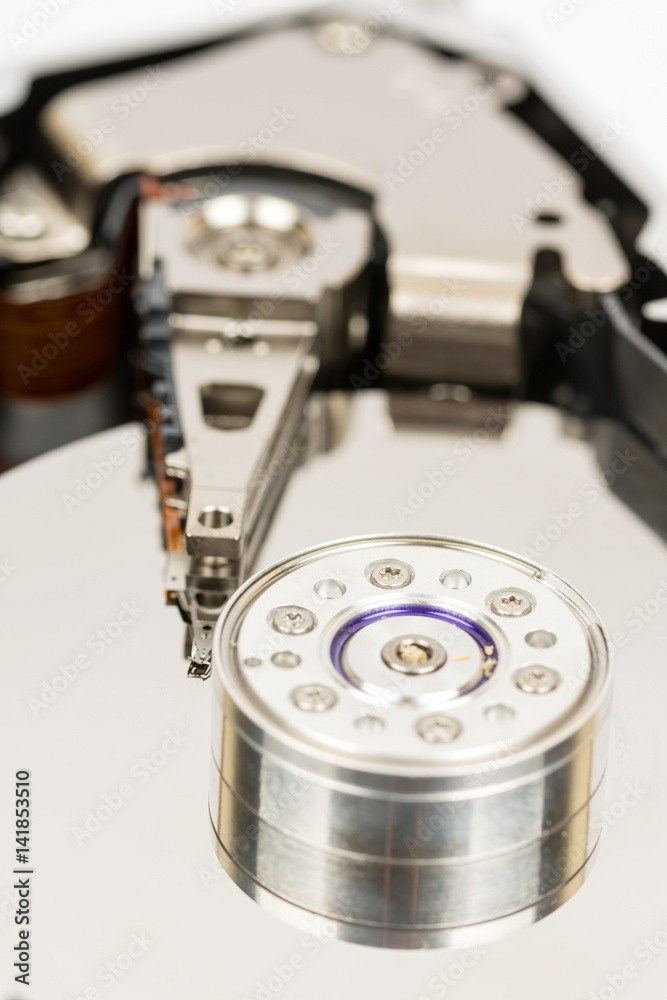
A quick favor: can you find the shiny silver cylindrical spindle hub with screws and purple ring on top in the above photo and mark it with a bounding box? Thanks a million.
[210,536,610,948]
